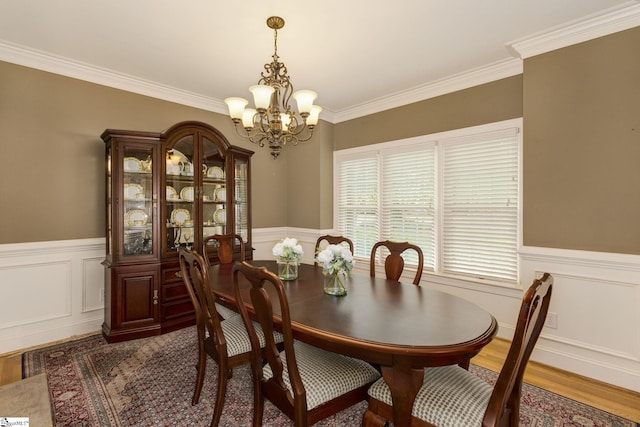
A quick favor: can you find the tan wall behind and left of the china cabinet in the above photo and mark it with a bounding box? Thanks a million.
[0,62,286,243]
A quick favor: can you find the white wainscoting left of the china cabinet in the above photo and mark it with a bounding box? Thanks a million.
[0,239,105,354]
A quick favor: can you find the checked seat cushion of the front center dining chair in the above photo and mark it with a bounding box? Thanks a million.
[263,341,380,410]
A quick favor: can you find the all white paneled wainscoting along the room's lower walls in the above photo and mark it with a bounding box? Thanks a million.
[0,234,640,392]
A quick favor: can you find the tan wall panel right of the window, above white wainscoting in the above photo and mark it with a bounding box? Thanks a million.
[523,27,640,254]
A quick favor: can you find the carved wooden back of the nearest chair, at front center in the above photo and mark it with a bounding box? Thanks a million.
[233,261,307,419]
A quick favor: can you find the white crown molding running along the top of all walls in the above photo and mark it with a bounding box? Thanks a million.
[0,0,640,123]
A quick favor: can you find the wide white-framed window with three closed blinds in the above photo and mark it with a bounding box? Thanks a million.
[334,120,521,282]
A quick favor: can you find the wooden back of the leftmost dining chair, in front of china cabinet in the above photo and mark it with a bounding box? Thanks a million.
[178,247,227,355]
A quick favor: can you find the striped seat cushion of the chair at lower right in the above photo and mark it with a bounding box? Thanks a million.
[369,365,493,427]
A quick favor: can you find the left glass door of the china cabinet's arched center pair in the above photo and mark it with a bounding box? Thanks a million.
[163,135,195,250]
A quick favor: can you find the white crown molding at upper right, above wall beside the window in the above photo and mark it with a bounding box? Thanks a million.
[507,0,640,59]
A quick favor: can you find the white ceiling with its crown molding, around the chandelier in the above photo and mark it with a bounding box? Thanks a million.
[0,0,640,122]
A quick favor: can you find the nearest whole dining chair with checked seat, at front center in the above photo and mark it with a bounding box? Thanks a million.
[233,262,380,427]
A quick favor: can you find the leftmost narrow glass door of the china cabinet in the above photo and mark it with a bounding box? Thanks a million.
[121,144,156,258]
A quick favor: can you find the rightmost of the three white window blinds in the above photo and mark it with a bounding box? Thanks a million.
[440,129,519,281]
